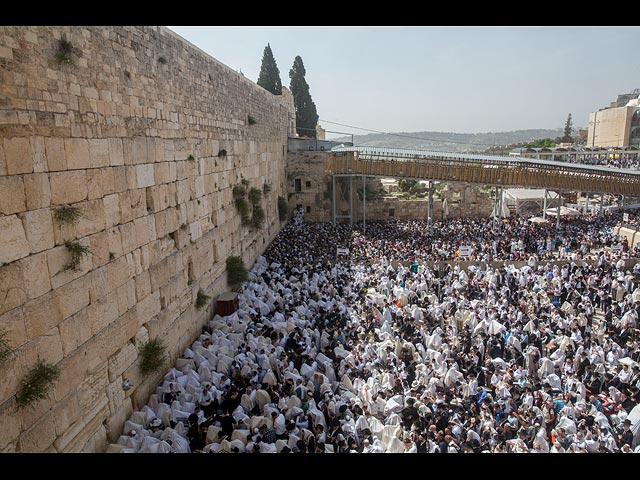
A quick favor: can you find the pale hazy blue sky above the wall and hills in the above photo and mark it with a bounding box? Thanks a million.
[169,27,640,137]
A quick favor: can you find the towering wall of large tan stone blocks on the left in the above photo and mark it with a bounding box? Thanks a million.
[0,27,288,452]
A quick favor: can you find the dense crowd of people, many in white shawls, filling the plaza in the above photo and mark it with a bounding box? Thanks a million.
[109,210,640,453]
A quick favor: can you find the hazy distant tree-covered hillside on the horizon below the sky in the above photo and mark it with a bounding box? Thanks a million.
[331,128,563,152]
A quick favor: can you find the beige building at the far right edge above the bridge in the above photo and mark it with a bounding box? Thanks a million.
[587,88,640,148]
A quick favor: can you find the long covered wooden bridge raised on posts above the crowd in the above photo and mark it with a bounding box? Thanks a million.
[327,147,640,196]
